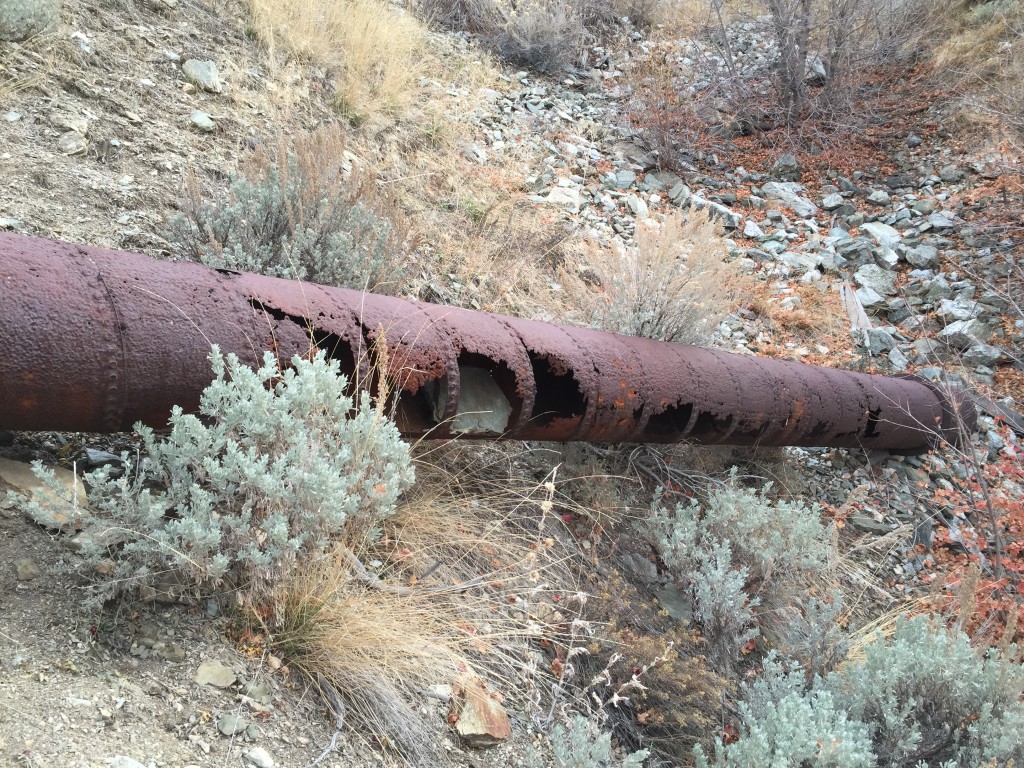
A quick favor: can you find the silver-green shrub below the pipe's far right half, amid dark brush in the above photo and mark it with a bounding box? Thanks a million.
[650,475,834,676]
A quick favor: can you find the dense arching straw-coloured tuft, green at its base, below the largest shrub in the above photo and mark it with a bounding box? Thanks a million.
[270,549,466,766]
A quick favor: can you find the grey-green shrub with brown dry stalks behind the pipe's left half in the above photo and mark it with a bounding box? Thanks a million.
[170,131,406,292]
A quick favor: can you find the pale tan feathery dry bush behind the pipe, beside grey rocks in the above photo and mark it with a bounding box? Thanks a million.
[562,212,745,344]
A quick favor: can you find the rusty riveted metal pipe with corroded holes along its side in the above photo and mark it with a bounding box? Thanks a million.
[0,234,976,451]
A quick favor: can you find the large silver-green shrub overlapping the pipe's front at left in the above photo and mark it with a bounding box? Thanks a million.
[74,347,414,602]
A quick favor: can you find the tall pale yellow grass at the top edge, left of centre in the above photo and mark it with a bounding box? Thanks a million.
[250,0,428,122]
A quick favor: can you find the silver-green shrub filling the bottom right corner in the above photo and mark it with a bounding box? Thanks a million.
[695,616,1024,768]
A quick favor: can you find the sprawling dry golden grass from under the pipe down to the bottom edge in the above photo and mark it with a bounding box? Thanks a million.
[264,444,567,766]
